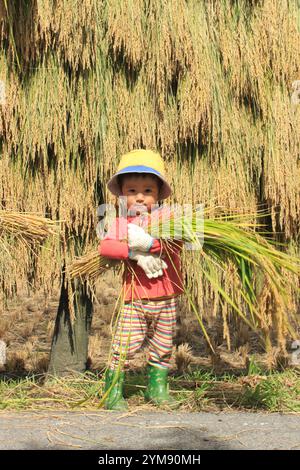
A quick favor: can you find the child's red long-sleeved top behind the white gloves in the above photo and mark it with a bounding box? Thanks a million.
[98,212,183,302]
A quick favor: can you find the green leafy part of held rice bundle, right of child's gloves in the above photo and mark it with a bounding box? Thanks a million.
[151,208,300,350]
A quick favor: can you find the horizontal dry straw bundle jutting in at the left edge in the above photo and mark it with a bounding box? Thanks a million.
[0,210,57,243]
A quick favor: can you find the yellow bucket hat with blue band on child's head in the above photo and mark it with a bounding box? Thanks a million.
[107,149,172,199]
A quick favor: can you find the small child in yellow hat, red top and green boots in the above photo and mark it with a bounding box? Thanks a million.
[99,150,183,410]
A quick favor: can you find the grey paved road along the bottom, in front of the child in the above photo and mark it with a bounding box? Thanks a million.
[0,410,300,450]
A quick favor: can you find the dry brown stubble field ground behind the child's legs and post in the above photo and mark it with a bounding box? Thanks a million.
[0,272,292,373]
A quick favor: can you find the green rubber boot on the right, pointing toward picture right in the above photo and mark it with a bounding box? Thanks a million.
[145,365,178,408]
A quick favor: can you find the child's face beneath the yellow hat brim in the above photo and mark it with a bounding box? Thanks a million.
[122,175,159,215]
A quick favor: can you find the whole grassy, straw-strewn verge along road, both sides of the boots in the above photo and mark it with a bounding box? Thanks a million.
[0,361,300,412]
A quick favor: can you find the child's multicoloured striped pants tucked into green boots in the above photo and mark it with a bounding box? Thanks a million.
[110,297,177,369]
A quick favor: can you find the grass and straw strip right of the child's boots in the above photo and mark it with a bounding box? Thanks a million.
[171,361,300,413]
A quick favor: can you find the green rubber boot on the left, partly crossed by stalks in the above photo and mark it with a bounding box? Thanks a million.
[104,369,128,411]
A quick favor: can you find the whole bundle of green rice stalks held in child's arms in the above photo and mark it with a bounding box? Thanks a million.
[71,206,300,350]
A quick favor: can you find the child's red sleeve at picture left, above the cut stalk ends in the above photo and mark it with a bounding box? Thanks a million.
[98,218,128,259]
